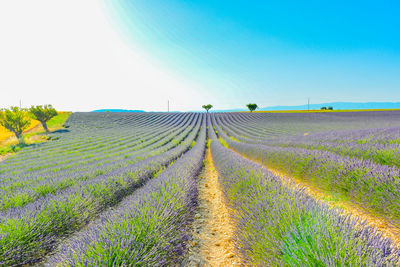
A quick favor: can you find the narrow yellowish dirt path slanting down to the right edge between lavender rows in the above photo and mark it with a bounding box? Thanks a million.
[229,148,400,248]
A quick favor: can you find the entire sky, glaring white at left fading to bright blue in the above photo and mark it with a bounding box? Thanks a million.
[0,0,400,111]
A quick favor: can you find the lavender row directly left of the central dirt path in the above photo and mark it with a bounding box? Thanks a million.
[47,116,206,266]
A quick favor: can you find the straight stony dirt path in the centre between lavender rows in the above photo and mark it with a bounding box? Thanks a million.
[186,149,240,266]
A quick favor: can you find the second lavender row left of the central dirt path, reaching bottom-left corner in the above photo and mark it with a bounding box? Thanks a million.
[0,113,200,266]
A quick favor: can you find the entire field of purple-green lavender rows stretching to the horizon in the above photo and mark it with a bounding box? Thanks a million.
[0,111,400,266]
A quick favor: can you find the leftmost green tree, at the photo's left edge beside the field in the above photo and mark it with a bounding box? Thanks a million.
[0,107,31,144]
